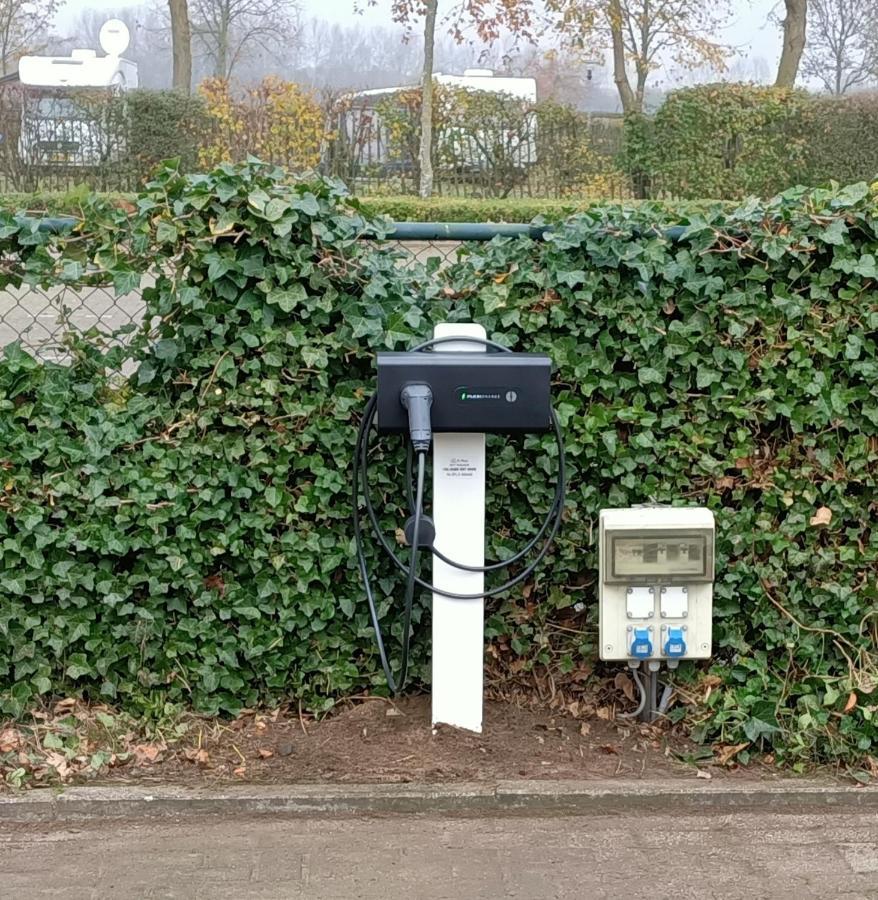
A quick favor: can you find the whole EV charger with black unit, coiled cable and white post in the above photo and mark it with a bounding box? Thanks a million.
[353,323,565,732]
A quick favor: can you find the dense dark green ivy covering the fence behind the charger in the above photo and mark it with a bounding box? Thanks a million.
[0,161,878,765]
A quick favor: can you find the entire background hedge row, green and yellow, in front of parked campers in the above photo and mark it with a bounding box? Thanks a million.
[8,78,878,201]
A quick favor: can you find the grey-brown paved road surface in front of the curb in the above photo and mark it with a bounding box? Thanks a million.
[0,812,878,900]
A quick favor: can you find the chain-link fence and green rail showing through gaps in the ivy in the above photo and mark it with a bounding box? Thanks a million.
[0,230,492,360]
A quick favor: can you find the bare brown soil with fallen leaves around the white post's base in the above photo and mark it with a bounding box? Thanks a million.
[93,697,772,784]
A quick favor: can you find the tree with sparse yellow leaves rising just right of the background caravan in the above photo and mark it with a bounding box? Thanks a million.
[546,0,730,113]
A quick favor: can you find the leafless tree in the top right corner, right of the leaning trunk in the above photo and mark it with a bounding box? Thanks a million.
[802,0,878,94]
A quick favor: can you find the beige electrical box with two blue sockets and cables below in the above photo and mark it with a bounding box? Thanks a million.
[598,506,716,721]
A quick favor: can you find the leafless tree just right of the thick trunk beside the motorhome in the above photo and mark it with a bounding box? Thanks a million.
[190,0,299,78]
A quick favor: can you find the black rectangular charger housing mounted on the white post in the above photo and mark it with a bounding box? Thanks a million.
[378,351,552,434]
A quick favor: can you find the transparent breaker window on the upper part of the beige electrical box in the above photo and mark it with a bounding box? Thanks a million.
[607,532,713,581]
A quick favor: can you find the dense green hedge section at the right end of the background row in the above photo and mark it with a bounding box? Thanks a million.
[623,84,878,199]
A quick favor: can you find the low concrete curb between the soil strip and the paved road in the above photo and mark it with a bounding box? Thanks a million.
[0,778,878,823]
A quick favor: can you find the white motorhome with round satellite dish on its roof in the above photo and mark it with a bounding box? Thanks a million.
[18,19,137,166]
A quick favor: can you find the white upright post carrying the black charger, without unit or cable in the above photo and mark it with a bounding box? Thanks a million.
[432,323,486,732]
